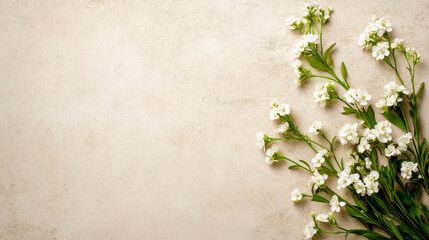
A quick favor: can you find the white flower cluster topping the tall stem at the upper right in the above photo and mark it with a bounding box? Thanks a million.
[358,16,392,50]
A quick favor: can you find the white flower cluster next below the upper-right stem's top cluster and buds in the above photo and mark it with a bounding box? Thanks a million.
[375,81,410,111]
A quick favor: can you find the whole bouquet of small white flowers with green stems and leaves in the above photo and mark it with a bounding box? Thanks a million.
[256,1,429,240]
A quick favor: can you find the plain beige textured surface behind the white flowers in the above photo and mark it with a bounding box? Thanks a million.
[0,0,429,240]
